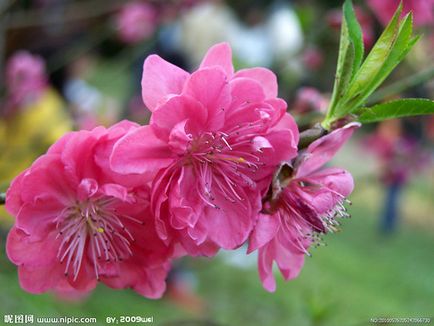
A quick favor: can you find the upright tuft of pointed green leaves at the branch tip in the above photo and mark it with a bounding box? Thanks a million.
[321,0,418,130]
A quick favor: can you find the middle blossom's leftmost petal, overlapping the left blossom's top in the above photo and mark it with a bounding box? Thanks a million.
[110,126,173,175]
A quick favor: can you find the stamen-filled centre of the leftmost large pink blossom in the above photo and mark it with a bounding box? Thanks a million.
[57,197,143,281]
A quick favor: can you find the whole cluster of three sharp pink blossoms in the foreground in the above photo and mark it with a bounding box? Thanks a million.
[6,43,358,298]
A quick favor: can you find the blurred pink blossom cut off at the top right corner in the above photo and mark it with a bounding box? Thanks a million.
[368,0,434,26]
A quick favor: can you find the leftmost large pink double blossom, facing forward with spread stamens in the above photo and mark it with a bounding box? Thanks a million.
[6,121,171,298]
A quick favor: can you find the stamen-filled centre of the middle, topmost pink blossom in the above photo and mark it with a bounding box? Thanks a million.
[183,123,265,209]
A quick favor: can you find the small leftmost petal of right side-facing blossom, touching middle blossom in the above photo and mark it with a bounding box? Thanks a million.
[247,214,280,254]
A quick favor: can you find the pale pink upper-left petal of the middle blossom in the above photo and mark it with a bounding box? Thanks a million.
[142,55,189,111]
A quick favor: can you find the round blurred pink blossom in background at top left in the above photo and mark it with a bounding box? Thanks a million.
[116,1,157,43]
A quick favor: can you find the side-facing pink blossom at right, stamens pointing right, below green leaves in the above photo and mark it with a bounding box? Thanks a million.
[248,123,359,291]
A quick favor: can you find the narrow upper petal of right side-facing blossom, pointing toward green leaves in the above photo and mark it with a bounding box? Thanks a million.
[297,122,360,177]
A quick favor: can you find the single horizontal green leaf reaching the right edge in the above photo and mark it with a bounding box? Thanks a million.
[357,98,434,123]
